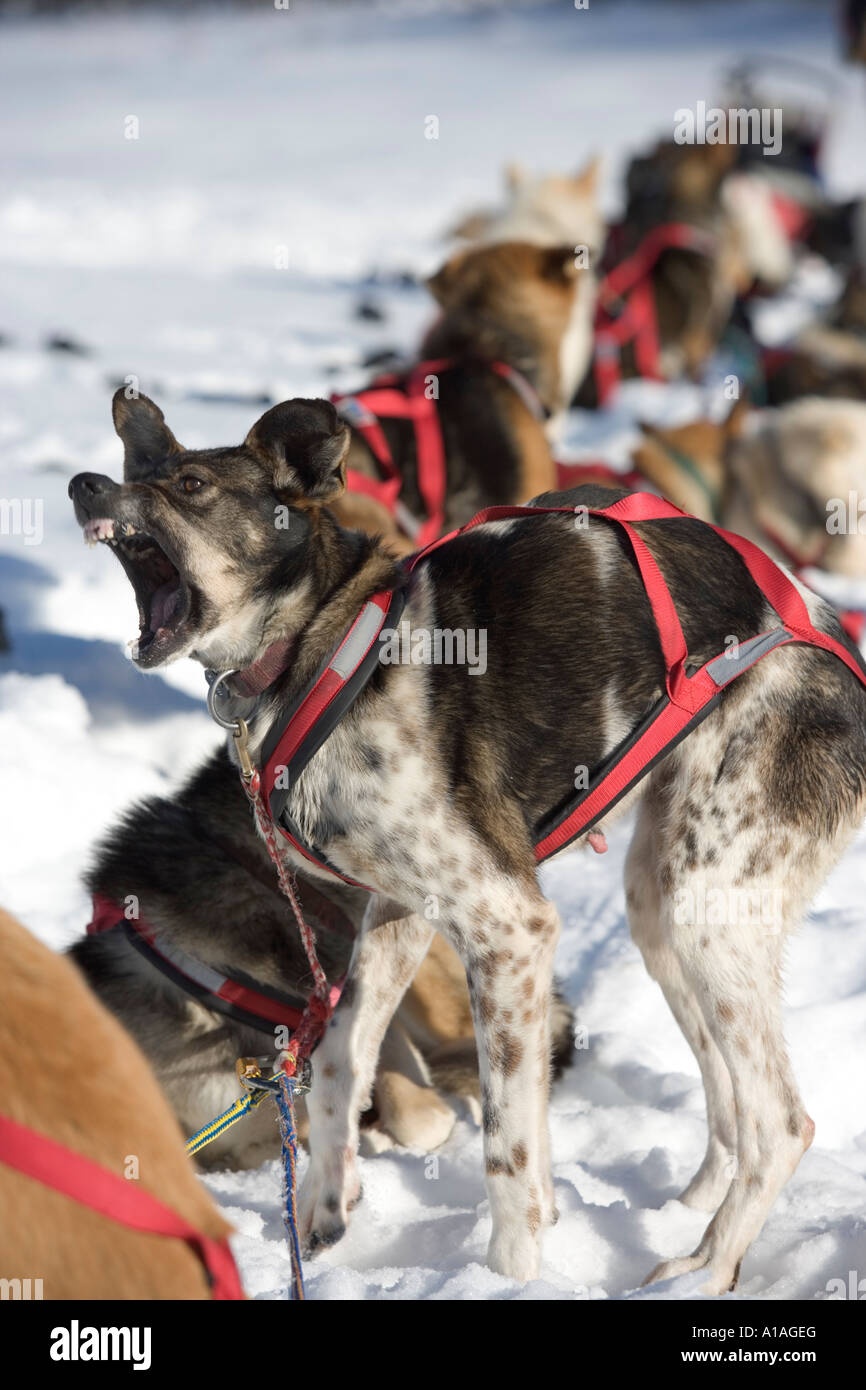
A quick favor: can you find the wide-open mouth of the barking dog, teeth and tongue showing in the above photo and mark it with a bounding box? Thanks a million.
[83,517,190,666]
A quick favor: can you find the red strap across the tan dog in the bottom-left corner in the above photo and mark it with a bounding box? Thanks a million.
[0,1115,243,1301]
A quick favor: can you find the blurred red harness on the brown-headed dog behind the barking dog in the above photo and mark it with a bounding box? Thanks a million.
[331,357,545,548]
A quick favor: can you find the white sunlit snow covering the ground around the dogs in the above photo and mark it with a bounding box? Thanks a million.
[0,3,866,1300]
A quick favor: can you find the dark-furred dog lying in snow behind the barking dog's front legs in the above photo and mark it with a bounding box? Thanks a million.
[71,749,573,1168]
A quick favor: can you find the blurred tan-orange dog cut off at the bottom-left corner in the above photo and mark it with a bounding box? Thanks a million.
[0,912,240,1300]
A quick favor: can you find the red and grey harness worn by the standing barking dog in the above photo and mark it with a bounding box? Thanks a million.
[246,492,866,891]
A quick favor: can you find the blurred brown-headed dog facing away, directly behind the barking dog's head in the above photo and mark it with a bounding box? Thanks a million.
[328,240,595,553]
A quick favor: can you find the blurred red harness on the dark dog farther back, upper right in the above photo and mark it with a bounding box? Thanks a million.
[594,222,714,406]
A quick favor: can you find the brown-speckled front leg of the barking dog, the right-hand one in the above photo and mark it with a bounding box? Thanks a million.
[453,885,559,1280]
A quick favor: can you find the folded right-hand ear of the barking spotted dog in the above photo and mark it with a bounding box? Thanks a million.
[245,398,352,502]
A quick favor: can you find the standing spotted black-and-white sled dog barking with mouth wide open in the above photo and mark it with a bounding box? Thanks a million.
[70,398,866,1291]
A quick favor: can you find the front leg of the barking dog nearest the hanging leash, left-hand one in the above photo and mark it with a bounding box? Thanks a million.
[299,897,432,1252]
